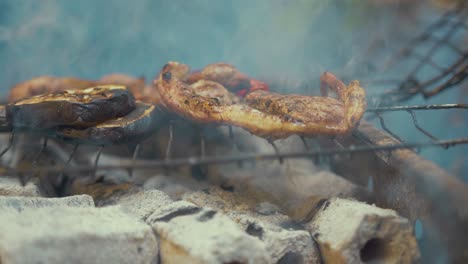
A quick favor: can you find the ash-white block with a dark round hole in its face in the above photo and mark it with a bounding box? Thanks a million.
[306,198,420,263]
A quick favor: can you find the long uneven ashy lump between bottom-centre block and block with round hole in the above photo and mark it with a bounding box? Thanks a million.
[184,188,319,263]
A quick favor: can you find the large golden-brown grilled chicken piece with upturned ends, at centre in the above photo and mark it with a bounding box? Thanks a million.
[154,62,366,139]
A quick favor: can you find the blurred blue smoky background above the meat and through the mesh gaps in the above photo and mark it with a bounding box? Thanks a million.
[0,0,468,178]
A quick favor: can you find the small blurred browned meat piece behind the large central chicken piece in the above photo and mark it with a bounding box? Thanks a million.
[185,62,268,96]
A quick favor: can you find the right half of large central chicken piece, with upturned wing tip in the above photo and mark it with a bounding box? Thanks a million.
[245,72,367,135]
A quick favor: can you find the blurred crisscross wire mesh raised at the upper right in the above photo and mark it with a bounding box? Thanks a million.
[371,5,468,105]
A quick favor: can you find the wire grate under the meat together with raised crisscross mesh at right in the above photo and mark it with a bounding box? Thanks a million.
[0,6,468,182]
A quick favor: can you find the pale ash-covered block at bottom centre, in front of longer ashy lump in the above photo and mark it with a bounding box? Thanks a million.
[152,208,272,263]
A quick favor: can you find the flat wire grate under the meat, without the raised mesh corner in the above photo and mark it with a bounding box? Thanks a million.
[0,104,468,175]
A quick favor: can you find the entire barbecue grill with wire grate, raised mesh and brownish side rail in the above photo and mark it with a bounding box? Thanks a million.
[0,2,468,263]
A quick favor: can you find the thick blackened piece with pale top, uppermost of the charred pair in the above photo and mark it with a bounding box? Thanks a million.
[5,85,135,129]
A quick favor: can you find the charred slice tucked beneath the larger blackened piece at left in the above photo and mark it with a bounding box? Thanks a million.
[56,102,161,145]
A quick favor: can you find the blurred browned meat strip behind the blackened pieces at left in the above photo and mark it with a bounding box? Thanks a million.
[8,73,158,104]
